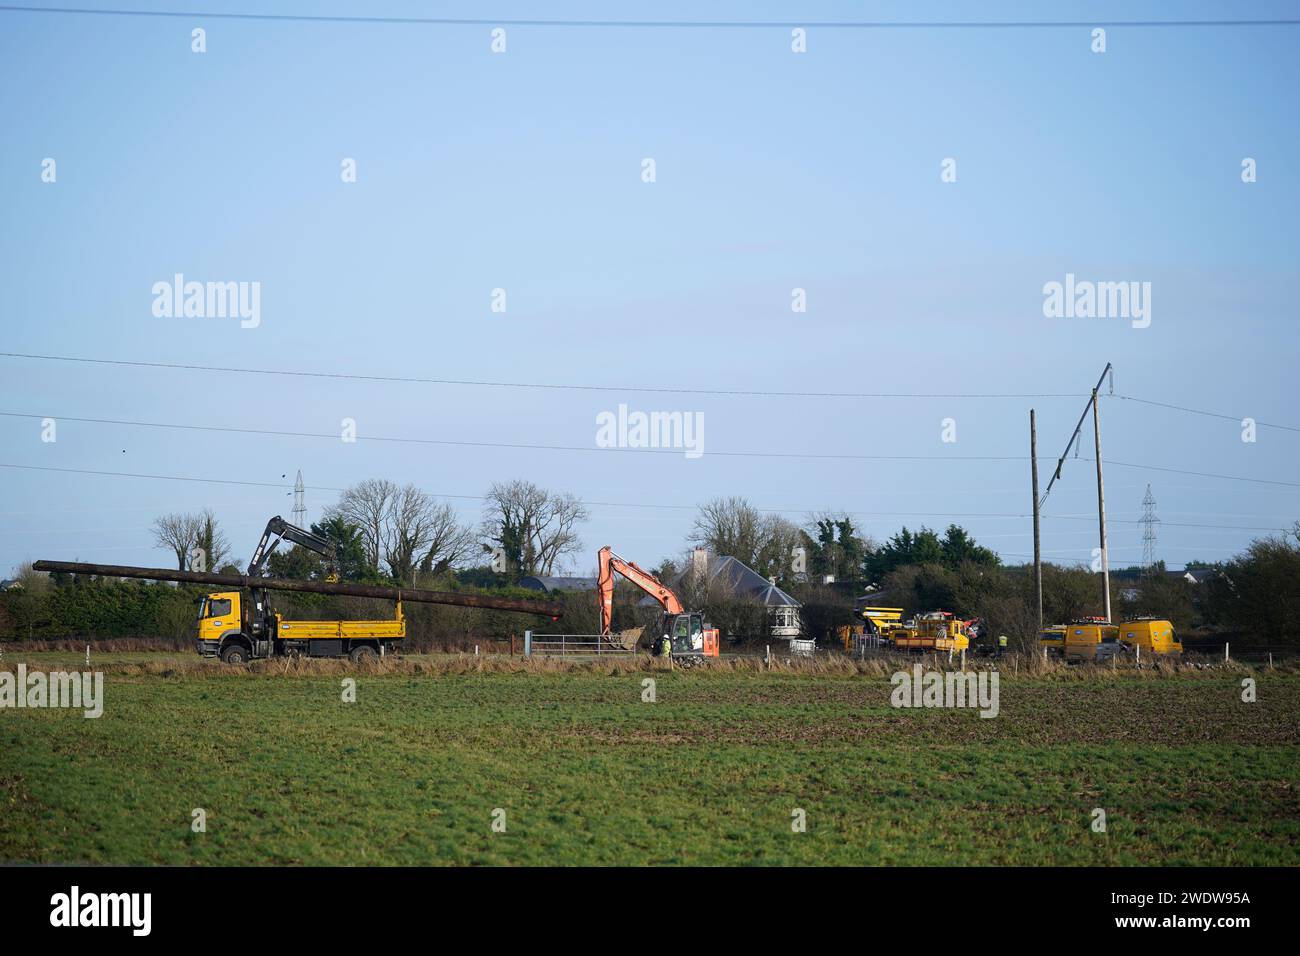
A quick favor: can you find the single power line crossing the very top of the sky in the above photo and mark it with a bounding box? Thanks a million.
[0,4,1300,30]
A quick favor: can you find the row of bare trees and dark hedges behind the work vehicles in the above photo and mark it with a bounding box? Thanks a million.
[0,479,1300,646]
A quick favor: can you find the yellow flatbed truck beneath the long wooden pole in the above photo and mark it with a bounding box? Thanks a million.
[196,588,406,663]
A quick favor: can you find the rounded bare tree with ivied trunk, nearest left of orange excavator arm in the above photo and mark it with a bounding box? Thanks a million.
[481,480,589,575]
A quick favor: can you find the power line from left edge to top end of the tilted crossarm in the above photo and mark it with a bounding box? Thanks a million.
[0,352,1084,399]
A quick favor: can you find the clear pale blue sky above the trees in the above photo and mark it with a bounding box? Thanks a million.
[0,0,1300,574]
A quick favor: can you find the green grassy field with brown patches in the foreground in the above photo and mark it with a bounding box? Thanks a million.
[0,648,1300,865]
